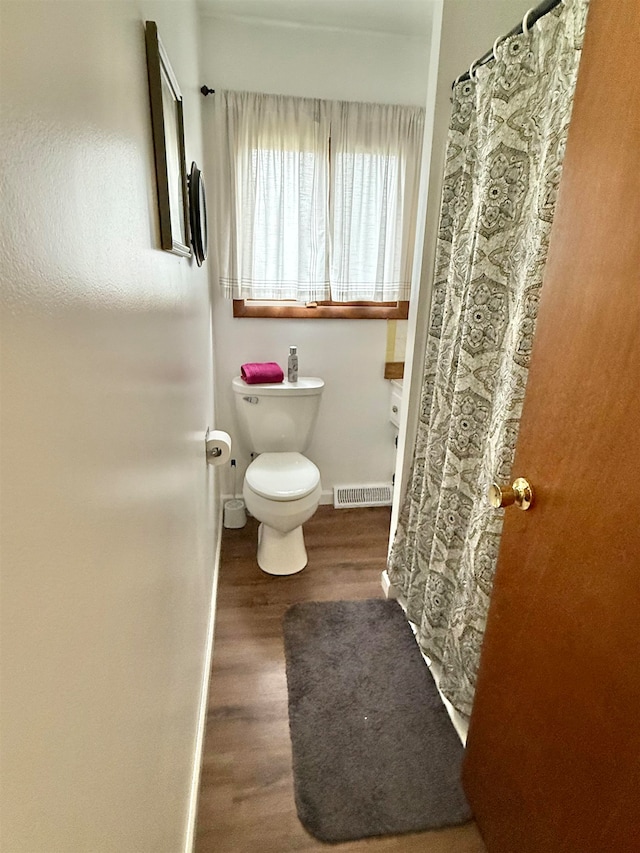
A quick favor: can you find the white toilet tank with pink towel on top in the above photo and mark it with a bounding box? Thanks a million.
[232,376,324,453]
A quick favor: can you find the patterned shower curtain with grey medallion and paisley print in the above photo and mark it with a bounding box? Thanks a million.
[389,0,588,714]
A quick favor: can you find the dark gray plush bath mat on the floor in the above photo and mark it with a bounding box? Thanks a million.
[284,599,471,842]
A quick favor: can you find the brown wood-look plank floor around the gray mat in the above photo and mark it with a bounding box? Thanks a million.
[196,506,486,853]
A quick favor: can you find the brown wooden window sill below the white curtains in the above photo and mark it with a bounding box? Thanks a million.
[233,299,409,320]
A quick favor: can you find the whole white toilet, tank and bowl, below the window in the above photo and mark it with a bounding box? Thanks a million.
[232,376,324,575]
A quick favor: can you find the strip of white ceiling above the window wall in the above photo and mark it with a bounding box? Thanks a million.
[198,0,437,37]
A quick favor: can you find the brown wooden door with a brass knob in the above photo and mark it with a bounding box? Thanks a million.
[463,0,640,853]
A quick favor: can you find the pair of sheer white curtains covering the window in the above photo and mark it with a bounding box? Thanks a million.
[213,91,424,302]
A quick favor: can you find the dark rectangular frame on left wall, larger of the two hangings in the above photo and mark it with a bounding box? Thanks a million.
[145,21,191,257]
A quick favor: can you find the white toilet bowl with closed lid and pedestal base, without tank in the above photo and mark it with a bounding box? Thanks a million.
[243,452,322,575]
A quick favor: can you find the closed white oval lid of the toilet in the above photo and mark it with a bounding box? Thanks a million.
[245,453,320,501]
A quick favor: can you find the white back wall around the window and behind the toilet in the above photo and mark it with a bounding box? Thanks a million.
[200,13,429,500]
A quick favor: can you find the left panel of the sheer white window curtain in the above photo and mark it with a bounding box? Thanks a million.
[213,91,330,302]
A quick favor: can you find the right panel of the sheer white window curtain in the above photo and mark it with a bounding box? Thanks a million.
[330,101,424,302]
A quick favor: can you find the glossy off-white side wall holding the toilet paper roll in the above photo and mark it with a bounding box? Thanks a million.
[0,0,219,853]
